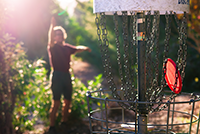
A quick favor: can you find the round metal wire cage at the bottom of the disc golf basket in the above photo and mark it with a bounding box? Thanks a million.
[87,89,200,134]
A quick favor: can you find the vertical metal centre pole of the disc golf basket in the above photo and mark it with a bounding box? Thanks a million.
[137,12,147,134]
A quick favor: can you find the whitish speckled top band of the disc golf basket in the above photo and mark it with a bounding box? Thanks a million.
[93,0,190,14]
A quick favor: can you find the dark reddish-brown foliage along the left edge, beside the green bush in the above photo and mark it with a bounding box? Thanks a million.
[0,34,28,134]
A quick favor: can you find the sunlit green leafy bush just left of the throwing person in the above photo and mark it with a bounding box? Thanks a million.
[13,59,51,131]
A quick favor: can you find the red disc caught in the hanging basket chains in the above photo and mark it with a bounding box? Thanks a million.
[164,58,182,94]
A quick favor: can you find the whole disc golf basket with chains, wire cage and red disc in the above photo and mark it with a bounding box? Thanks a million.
[87,0,200,134]
